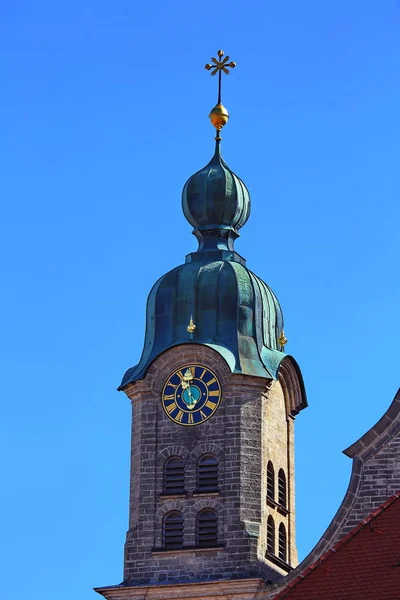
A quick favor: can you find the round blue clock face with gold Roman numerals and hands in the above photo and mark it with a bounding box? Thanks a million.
[162,365,221,426]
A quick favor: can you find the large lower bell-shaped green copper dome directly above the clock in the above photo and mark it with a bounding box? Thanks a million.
[121,260,285,387]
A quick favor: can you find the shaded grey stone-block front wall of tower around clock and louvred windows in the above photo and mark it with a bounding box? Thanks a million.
[120,344,296,585]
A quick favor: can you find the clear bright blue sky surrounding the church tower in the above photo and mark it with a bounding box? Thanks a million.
[0,0,400,600]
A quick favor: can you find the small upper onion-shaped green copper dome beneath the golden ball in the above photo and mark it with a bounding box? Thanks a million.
[182,140,250,252]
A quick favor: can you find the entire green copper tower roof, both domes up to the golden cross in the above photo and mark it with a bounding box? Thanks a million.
[120,50,305,402]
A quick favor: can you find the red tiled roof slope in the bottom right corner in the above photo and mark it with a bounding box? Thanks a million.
[274,492,400,600]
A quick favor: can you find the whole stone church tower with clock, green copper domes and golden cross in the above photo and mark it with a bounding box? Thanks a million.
[96,50,307,600]
